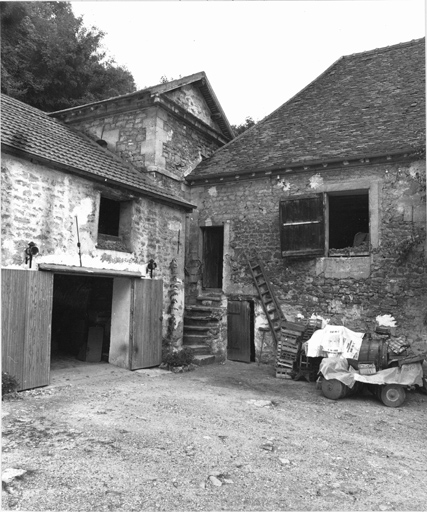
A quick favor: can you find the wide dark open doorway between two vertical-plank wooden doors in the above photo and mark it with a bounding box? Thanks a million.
[51,274,113,363]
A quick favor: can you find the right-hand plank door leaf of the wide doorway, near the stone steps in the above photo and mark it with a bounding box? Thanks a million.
[130,279,163,370]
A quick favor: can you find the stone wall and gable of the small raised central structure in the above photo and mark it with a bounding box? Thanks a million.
[68,86,223,194]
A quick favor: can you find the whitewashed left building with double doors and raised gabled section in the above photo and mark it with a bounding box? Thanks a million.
[1,73,233,389]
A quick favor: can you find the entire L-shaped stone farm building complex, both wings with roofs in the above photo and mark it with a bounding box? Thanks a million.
[2,40,427,388]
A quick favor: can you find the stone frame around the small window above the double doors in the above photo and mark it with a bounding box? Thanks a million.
[96,193,134,253]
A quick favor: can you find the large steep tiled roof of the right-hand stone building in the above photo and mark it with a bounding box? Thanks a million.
[192,38,426,180]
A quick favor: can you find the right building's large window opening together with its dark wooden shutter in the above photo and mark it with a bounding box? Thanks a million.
[280,184,378,257]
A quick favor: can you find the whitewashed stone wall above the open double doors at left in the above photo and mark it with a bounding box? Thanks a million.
[1,154,185,344]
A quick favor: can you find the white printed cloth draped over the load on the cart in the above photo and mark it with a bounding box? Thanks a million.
[305,325,364,359]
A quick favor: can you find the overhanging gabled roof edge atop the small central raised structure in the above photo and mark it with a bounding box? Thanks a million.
[49,71,234,140]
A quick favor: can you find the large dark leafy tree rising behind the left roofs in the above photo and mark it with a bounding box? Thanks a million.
[0,2,135,111]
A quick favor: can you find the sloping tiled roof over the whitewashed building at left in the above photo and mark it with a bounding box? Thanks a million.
[1,94,195,208]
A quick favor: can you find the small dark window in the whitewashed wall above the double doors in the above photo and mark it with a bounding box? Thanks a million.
[97,196,132,252]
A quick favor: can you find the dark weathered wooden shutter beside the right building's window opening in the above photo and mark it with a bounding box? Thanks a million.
[280,194,325,257]
